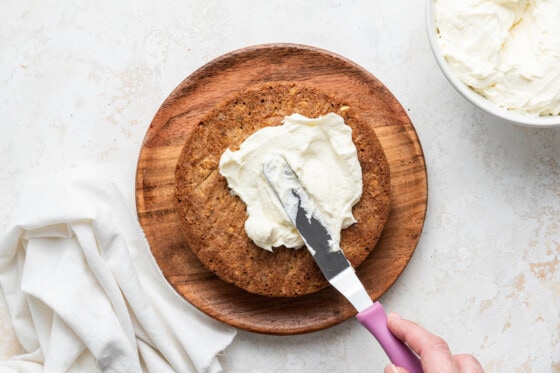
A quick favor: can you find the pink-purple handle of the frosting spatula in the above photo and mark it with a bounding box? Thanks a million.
[356,302,422,373]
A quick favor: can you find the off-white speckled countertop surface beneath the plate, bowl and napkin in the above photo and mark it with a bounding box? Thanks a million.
[0,0,560,372]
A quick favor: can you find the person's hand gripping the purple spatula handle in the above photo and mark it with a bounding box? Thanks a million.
[384,313,484,373]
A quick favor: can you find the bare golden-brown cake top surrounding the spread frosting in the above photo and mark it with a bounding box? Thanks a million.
[175,82,390,297]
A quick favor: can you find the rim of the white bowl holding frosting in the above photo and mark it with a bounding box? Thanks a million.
[426,0,560,127]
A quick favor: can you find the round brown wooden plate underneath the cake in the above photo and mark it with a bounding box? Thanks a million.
[136,44,427,335]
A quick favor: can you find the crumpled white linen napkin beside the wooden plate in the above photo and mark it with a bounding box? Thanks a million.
[0,168,235,372]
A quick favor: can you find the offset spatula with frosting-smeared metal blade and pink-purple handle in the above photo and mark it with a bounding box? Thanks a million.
[263,155,422,373]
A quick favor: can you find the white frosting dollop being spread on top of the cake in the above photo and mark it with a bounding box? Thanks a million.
[220,113,362,251]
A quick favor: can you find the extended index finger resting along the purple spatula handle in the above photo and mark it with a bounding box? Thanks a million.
[387,313,458,372]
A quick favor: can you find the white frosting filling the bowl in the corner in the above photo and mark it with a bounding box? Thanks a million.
[434,0,560,116]
